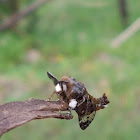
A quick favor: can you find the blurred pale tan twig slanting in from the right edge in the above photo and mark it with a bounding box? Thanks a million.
[111,18,140,48]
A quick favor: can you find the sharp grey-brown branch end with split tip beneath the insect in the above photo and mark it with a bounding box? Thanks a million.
[0,99,73,136]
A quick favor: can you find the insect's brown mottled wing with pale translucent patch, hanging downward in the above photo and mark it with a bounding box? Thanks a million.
[75,95,96,130]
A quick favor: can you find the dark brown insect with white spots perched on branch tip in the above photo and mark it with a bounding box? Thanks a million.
[47,72,109,130]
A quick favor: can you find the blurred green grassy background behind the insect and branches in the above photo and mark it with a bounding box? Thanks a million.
[0,0,140,140]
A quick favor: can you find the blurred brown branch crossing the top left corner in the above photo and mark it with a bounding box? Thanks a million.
[0,0,49,31]
